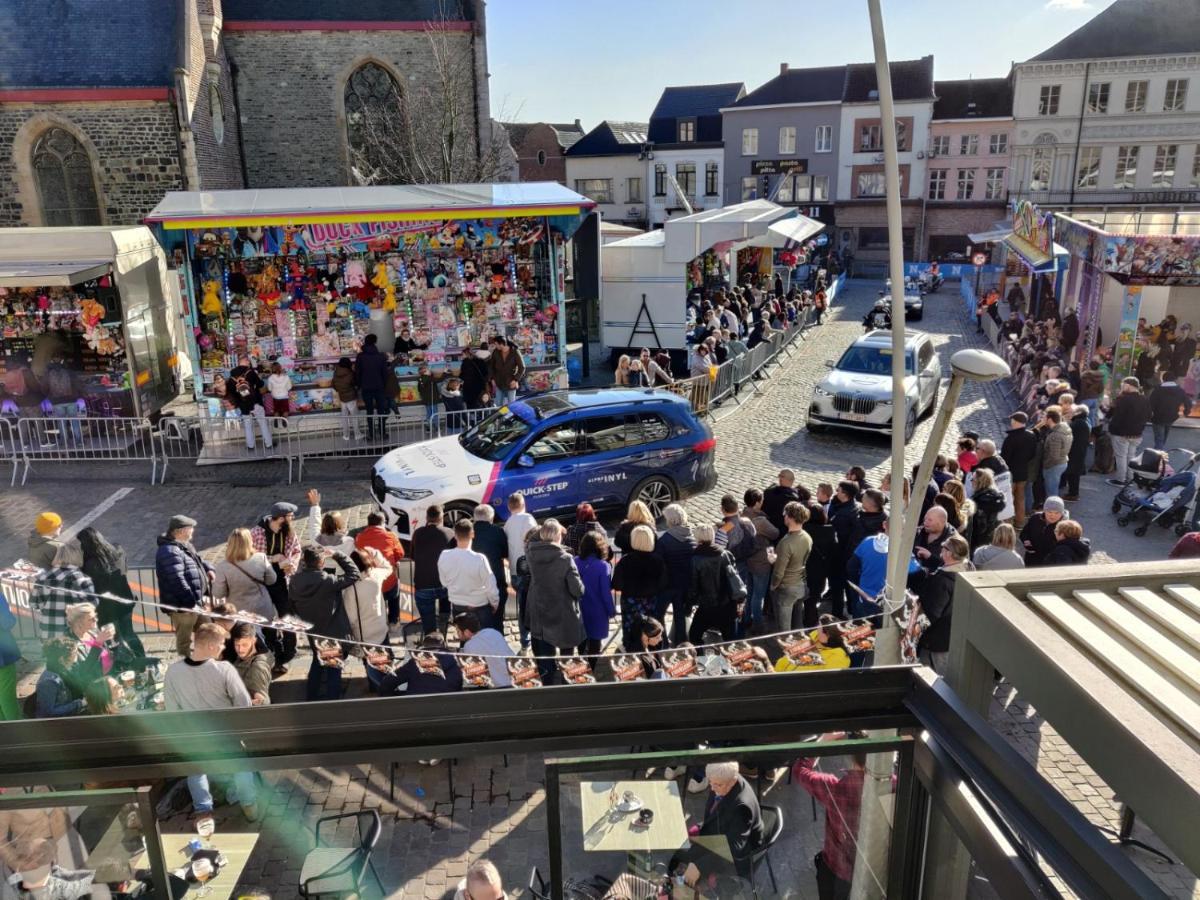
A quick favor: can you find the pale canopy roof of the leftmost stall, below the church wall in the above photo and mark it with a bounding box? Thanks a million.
[0,226,162,278]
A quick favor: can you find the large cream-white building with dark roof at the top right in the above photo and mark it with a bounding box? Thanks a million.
[1012,0,1200,230]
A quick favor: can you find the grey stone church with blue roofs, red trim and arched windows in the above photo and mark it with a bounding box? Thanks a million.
[0,0,491,226]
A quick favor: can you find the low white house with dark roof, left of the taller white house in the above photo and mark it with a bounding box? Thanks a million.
[564,121,647,228]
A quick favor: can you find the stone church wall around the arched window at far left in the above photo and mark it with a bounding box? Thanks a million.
[0,101,182,226]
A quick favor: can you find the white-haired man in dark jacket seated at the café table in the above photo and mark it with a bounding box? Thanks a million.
[667,761,766,887]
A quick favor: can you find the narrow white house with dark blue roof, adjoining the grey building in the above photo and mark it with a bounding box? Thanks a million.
[646,82,746,228]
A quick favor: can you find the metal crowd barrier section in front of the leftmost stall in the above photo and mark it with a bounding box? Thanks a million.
[14,415,158,485]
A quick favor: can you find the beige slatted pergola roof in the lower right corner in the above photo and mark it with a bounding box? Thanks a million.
[948,560,1200,871]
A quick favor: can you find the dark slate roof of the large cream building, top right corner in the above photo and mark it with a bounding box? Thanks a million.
[1030,0,1200,62]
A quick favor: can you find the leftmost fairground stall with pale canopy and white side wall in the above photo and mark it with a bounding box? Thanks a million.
[0,226,181,418]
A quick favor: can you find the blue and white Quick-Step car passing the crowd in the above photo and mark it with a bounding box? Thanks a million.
[371,389,716,538]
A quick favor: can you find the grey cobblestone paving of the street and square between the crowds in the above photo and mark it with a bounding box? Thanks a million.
[0,281,1200,899]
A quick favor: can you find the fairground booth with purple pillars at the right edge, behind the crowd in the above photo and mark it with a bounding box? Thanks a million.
[1055,214,1200,415]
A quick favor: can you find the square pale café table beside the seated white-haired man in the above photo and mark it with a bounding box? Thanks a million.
[580,781,688,872]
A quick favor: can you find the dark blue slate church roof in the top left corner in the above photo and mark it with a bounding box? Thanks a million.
[0,0,178,90]
